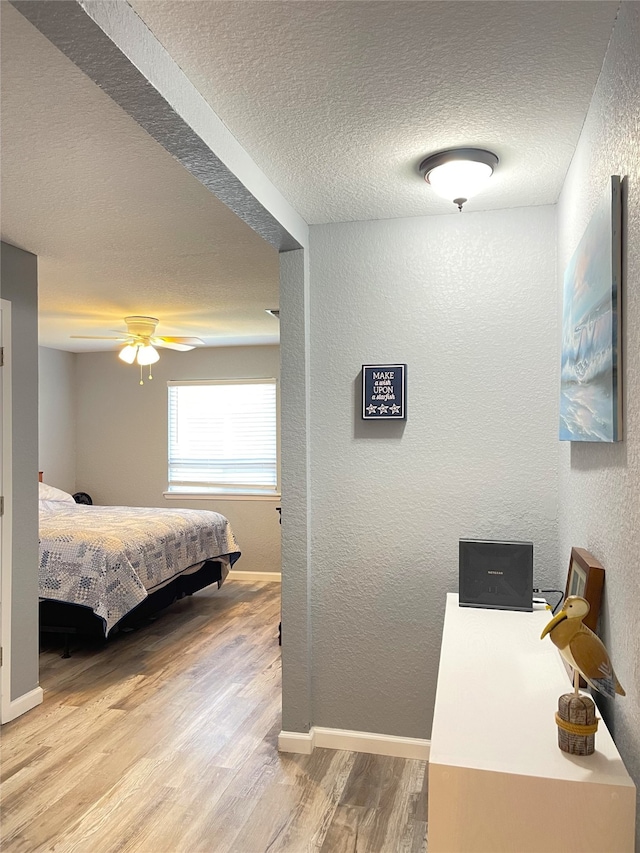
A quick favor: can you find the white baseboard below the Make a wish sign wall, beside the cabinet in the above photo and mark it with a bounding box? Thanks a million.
[278,726,431,761]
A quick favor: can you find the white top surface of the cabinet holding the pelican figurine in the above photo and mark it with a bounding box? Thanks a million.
[429,593,634,787]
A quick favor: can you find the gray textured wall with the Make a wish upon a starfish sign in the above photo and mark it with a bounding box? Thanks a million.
[310,207,558,738]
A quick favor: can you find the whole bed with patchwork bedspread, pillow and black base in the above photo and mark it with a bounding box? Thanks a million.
[39,483,240,655]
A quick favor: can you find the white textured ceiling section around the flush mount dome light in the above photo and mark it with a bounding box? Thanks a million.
[130,0,618,223]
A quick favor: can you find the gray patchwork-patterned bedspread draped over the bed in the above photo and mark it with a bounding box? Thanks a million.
[40,503,240,635]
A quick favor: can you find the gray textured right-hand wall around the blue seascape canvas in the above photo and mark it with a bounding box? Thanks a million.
[558,3,640,850]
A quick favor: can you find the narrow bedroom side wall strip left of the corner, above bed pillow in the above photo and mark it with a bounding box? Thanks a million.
[38,347,76,494]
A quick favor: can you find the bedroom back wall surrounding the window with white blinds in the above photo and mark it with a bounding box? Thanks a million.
[76,346,280,572]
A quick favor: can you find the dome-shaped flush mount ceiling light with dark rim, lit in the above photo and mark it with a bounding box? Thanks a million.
[419,148,498,212]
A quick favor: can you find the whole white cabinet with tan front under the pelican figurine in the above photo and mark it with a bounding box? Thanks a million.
[429,594,636,853]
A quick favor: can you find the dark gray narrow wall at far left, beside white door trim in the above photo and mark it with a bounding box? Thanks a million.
[0,243,38,700]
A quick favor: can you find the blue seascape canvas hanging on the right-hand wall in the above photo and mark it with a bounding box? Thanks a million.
[560,175,622,442]
